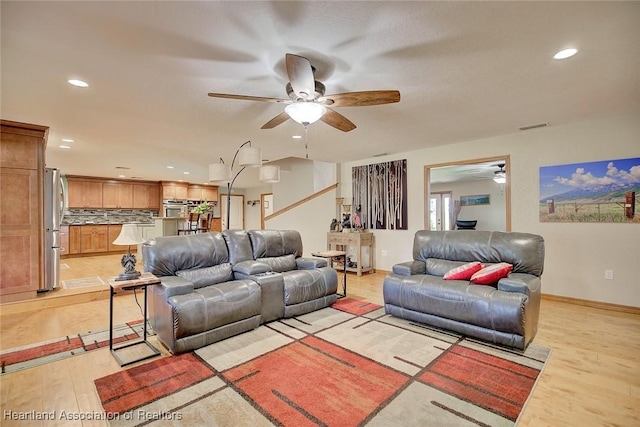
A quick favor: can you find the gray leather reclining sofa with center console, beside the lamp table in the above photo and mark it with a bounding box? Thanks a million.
[142,230,338,354]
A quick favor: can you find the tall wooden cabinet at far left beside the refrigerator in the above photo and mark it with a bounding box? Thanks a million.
[0,120,49,302]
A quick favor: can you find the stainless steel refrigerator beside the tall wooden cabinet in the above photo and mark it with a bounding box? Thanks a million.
[40,168,66,292]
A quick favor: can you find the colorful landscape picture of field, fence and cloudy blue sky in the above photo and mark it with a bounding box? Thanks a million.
[539,157,640,224]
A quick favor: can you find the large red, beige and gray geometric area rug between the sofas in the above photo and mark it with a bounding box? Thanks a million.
[95,298,550,427]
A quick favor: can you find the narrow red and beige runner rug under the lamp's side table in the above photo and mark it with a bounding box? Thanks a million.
[0,320,155,374]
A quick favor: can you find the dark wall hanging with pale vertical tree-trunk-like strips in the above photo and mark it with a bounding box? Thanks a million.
[351,159,407,230]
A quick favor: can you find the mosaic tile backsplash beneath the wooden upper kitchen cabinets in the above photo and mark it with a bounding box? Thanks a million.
[62,209,158,225]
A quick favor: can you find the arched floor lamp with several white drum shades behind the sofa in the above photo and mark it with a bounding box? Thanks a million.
[209,141,280,230]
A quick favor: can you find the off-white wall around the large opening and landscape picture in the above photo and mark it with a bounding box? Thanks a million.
[340,112,640,307]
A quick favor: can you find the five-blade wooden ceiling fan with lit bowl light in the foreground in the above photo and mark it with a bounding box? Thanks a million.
[209,53,400,132]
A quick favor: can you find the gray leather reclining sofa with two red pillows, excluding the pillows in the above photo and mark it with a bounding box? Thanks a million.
[383,230,544,349]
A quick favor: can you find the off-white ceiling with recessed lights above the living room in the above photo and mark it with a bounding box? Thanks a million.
[0,0,640,186]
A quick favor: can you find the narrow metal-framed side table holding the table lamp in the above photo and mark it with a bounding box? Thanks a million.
[109,273,160,366]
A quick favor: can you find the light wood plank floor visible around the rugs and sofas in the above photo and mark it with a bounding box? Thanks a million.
[0,255,640,427]
